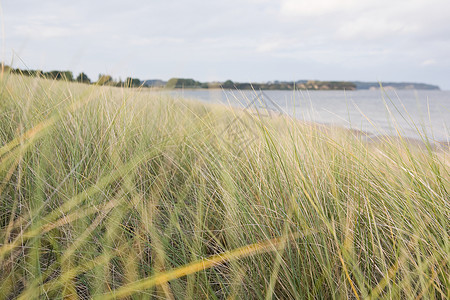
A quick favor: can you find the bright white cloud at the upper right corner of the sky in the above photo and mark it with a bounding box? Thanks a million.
[280,0,450,39]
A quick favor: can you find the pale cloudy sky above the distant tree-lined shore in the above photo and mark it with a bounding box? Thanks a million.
[0,0,450,90]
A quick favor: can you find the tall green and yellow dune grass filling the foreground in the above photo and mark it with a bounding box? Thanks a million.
[0,75,450,299]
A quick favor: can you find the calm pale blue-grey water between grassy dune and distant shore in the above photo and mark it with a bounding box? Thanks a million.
[156,90,450,142]
